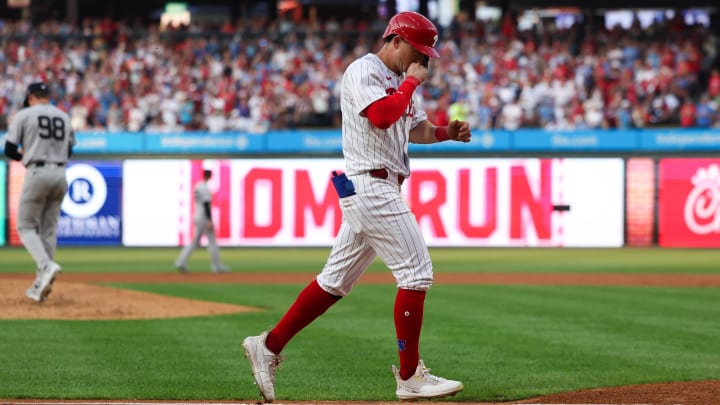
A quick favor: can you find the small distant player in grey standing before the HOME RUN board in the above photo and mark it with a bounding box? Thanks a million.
[175,170,230,273]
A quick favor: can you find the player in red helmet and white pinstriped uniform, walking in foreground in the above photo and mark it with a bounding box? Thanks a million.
[243,12,471,402]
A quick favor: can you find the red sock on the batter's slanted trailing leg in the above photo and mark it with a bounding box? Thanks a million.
[265,280,340,354]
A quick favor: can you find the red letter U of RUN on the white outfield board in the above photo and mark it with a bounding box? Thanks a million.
[458,167,497,238]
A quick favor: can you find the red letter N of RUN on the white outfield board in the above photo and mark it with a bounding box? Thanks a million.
[510,159,552,240]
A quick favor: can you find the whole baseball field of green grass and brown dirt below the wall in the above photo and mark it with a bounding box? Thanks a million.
[0,248,720,405]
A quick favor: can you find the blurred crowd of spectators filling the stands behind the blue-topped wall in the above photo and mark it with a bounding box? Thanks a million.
[0,14,720,133]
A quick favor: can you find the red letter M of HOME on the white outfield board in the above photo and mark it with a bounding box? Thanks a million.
[295,170,342,237]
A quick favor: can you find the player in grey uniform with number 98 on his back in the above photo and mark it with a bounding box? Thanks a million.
[5,83,75,302]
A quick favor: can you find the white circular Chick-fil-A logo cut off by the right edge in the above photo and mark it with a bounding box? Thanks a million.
[684,164,720,235]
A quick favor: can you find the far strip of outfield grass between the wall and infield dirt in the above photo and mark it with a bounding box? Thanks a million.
[0,247,720,273]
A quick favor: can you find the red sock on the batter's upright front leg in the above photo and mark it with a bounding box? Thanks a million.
[395,289,426,380]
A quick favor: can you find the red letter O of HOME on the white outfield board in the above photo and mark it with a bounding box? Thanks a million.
[243,169,282,238]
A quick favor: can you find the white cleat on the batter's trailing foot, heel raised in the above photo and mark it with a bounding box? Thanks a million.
[243,332,284,402]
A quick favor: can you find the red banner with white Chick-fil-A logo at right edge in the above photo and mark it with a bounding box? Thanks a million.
[658,158,720,247]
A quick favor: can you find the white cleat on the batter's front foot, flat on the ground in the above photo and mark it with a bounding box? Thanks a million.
[392,360,463,400]
